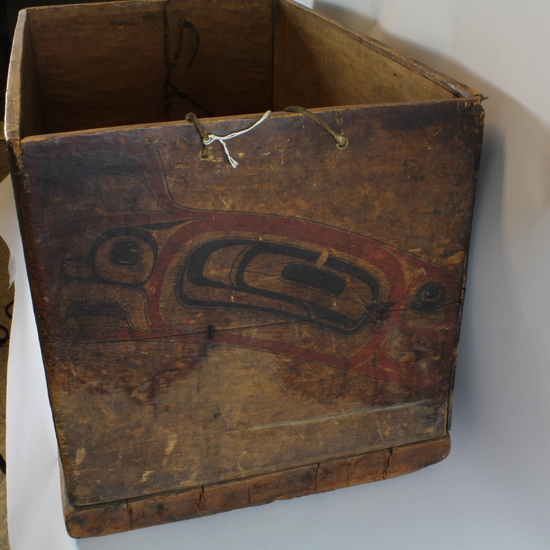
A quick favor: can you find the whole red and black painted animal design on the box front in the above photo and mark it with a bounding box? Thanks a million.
[37,149,461,398]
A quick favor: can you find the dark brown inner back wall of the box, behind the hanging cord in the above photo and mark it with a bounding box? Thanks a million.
[25,0,273,132]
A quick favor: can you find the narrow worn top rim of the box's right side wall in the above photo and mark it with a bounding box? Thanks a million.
[279,0,485,99]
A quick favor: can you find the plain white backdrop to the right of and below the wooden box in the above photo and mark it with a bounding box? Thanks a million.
[5,0,550,550]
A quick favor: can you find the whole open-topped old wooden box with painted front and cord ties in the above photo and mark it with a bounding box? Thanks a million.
[6,0,483,537]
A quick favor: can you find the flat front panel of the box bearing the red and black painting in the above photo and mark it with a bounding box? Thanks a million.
[9,101,479,505]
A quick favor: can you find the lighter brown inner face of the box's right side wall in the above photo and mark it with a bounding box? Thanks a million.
[273,0,476,109]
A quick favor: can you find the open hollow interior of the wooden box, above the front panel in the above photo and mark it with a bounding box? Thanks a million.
[10,0,464,138]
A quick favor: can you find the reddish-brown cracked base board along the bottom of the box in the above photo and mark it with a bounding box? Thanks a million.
[61,433,450,538]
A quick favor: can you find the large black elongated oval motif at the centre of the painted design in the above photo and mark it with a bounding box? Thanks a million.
[176,238,386,335]
